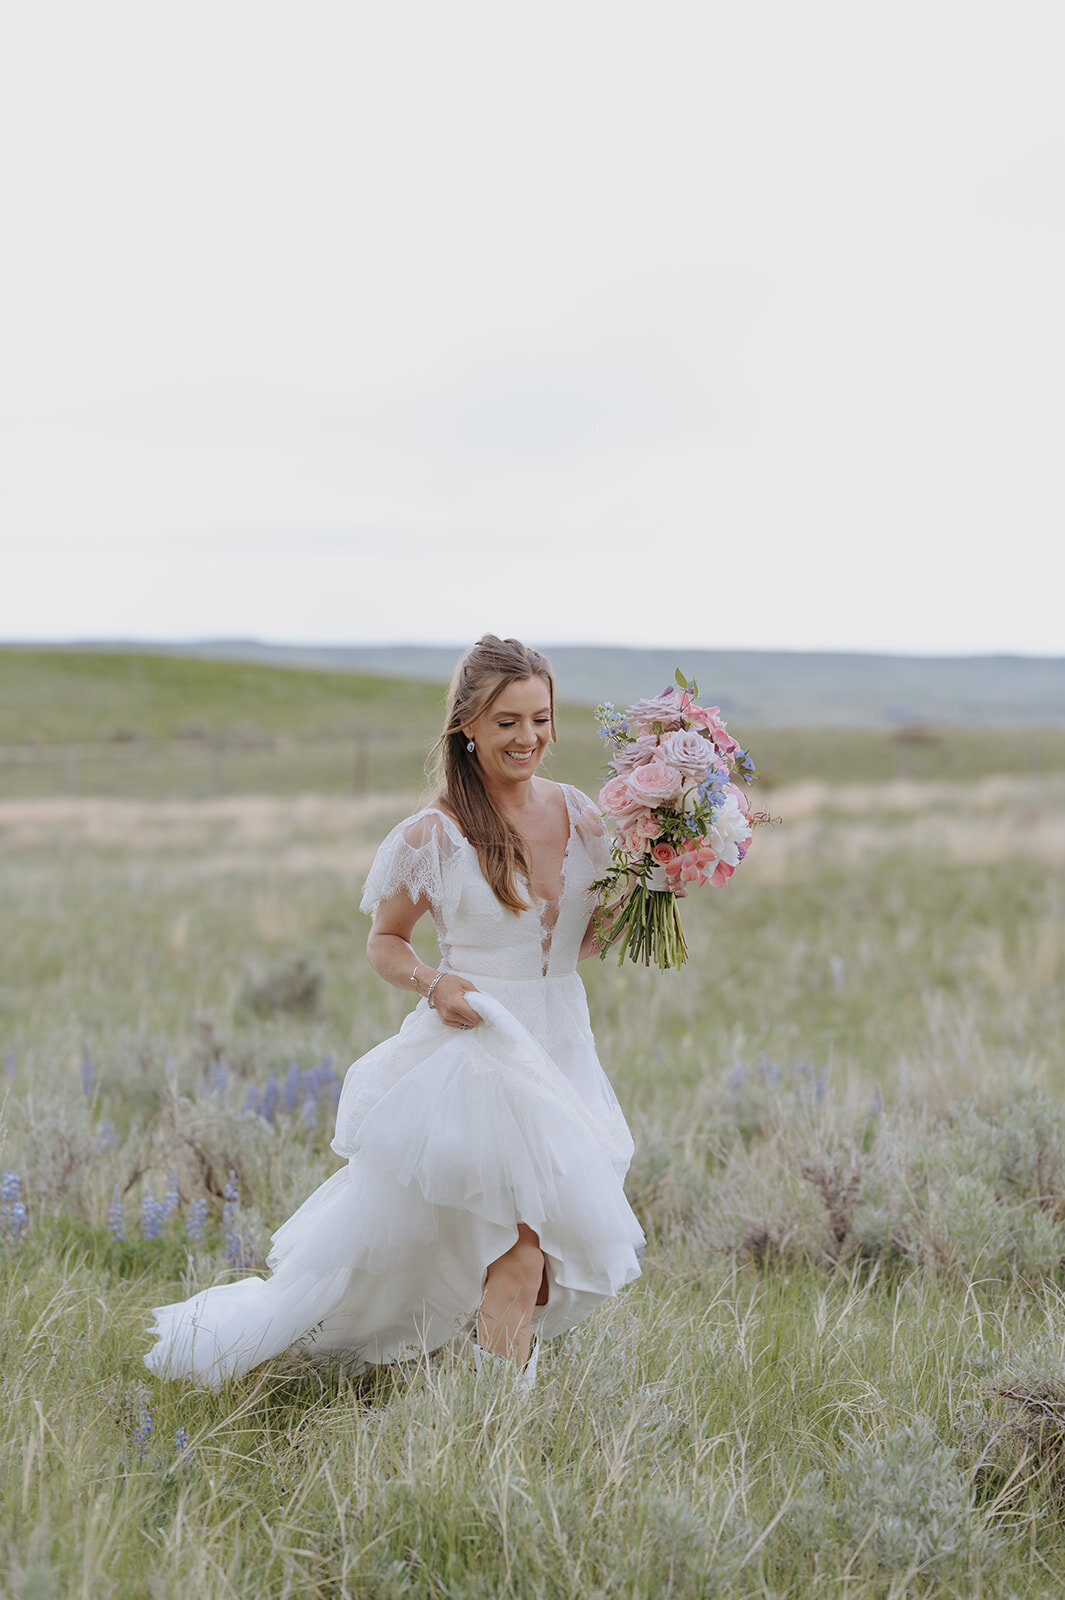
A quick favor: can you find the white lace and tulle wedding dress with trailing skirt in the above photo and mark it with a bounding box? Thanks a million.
[146,784,644,1386]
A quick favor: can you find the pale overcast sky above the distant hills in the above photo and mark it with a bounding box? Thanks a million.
[0,0,1065,654]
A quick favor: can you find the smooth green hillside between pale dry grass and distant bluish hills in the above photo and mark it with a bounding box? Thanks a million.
[0,650,1065,798]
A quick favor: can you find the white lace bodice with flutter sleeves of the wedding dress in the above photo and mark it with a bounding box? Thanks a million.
[361,784,609,979]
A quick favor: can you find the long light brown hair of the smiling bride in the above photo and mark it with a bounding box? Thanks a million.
[433,634,555,912]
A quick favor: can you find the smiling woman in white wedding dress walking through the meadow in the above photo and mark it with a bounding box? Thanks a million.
[146,634,644,1387]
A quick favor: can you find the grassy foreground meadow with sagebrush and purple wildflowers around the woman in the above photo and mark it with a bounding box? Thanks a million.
[0,656,1065,1600]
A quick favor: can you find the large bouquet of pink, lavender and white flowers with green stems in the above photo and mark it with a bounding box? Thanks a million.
[593,669,758,971]
